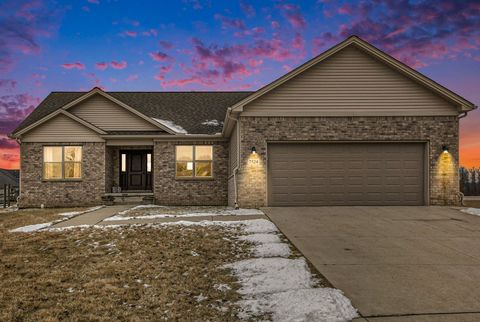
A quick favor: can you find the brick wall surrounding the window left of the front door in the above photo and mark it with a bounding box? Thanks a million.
[19,143,105,208]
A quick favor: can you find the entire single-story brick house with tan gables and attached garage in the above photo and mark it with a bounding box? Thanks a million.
[11,36,476,207]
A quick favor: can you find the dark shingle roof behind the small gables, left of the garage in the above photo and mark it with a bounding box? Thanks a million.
[13,92,252,134]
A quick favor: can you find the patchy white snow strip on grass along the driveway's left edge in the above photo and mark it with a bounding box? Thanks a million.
[225,219,358,321]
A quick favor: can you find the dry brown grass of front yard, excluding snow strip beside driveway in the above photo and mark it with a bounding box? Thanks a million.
[0,219,248,321]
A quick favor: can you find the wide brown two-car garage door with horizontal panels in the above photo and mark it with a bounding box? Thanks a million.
[268,143,425,206]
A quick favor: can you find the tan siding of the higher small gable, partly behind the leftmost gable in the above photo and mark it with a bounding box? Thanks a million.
[68,95,159,131]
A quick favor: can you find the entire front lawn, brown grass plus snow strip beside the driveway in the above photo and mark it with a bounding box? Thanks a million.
[0,210,356,321]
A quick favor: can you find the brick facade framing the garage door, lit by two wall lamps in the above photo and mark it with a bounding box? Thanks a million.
[237,116,459,207]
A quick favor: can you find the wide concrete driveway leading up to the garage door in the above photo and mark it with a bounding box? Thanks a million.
[262,207,480,321]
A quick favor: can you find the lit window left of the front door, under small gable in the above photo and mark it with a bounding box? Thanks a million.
[43,146,82,180]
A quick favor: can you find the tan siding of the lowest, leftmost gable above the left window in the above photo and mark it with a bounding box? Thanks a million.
[22,114,104,142]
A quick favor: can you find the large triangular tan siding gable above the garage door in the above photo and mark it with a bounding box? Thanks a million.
[243,46,458,116]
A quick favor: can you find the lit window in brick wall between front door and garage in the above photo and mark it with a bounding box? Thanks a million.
[176,145,213,178]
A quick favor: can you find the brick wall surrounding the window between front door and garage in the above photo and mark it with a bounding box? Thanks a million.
[153,141,228,205]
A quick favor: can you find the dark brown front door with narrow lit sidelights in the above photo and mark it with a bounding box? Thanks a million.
[120,150,152,190]
